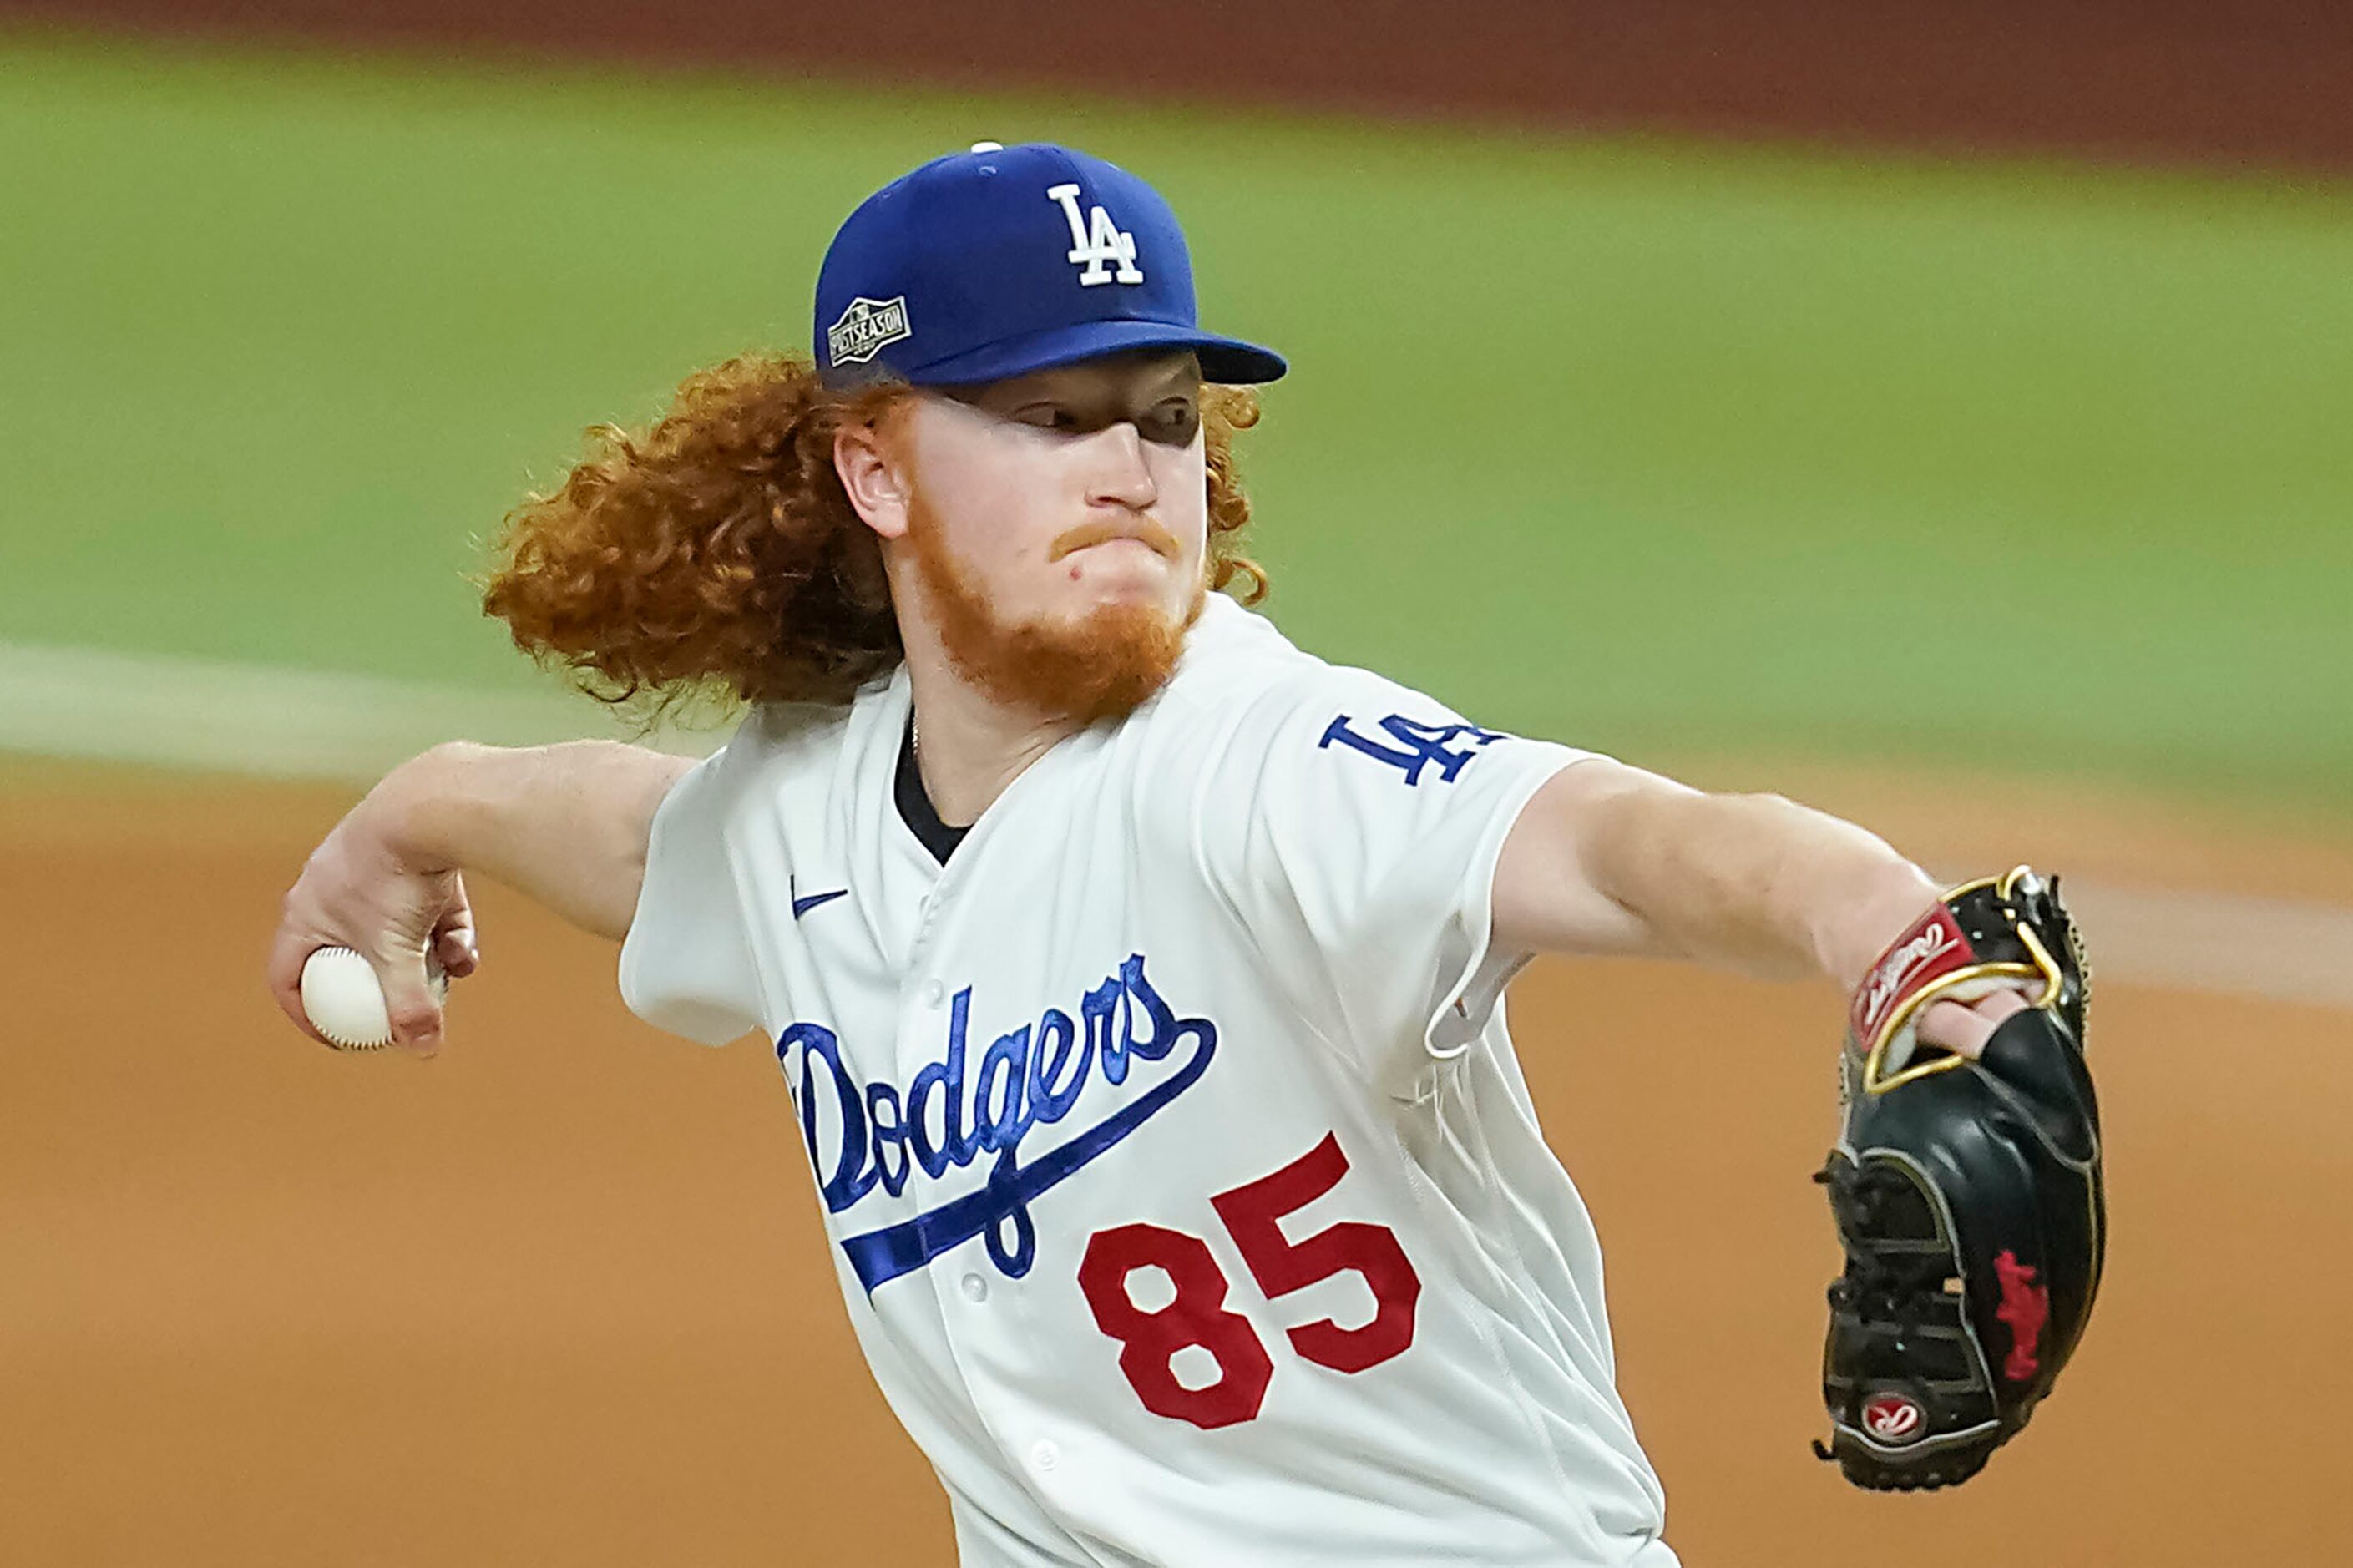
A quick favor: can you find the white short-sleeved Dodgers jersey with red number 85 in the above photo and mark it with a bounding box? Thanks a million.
[621,595,1675,1568]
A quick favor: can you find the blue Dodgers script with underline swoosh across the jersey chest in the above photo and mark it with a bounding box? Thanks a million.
[777,953,1217,1292]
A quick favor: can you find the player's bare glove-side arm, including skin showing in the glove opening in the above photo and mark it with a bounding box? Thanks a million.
[1494,758,2014,1055]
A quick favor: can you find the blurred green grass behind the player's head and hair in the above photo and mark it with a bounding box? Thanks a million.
[0,33,2353,807]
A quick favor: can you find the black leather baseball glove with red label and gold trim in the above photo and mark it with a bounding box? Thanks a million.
[1814,867,2108,1490]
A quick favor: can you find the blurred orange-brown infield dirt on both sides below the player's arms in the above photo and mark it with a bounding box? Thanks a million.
[0,765,2353,1568]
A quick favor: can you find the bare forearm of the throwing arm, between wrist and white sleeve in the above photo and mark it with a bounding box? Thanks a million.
[367,741,694,939]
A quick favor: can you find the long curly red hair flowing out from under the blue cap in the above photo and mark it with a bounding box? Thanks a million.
[483,353,1266,721]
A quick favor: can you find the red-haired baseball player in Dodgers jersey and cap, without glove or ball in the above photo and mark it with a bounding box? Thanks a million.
[271,144,2023,1568]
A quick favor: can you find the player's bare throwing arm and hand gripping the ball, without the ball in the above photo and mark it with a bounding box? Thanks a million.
[268,741,694,1052]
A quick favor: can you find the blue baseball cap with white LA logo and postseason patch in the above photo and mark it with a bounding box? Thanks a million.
[812,141,1287,386]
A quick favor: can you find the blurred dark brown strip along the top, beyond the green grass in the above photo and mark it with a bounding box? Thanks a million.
[13,0,2353,172]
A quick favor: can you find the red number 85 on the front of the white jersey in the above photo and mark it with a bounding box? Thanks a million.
[1078,1132,1421,1427]
